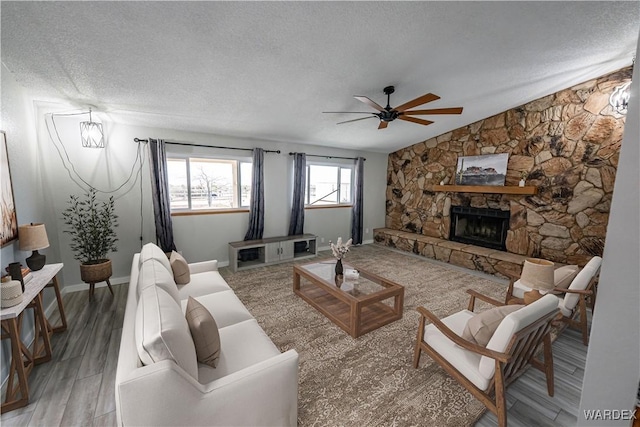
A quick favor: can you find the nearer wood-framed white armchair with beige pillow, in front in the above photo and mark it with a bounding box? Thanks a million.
[413,290,558,427]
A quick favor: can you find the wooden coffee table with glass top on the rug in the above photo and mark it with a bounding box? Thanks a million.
[293,261,404,338]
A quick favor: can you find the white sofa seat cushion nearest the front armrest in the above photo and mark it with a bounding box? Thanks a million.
[198,319,280,384]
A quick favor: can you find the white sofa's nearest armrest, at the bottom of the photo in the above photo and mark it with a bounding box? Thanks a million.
[116,350,298,426]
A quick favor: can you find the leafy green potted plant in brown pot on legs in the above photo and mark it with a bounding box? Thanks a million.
[64,188,118,293]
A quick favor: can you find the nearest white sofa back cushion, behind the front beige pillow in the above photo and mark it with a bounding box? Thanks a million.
[135,286,198,379]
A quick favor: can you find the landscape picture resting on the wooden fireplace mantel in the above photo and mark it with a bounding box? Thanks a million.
[456,153,509,185]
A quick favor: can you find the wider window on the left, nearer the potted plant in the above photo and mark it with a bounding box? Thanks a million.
[167,157,252,211]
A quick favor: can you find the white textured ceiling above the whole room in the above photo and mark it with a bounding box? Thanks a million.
[0,1,640,152]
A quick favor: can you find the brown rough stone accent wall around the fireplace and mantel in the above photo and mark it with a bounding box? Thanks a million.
[385,67,631,265]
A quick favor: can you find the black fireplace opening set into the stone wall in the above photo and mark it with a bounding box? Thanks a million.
[449,206,510,251]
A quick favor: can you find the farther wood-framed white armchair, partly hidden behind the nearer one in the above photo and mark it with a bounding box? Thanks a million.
[505,256,602,345]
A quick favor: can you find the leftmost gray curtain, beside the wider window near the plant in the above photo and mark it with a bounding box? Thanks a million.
[149,138,176,252]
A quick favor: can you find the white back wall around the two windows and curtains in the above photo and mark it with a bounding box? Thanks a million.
[31,104,387,286]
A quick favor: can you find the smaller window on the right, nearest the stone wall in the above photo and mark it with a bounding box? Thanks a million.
[305,164,353,206]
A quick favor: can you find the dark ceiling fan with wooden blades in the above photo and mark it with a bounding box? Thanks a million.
[323,86,462,129]
